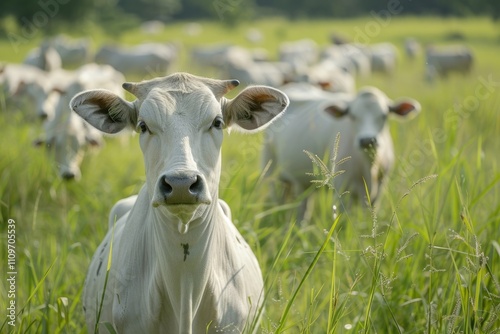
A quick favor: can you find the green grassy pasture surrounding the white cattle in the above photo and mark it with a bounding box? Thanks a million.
[0,17,500,333]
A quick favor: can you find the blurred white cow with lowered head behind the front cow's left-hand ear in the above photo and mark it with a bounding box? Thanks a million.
[35,63,125,180]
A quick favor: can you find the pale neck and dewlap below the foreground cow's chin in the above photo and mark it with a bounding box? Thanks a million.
[149,190,226,332]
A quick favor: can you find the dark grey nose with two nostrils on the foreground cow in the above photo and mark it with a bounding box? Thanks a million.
[159,172,206,204]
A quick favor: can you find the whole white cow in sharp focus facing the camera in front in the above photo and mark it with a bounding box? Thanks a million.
[71,73,288,333]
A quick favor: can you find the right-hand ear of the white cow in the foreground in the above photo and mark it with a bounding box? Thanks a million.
[222,86,289,132]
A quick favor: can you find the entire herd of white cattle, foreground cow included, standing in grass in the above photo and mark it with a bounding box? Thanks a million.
[0,30,473,333]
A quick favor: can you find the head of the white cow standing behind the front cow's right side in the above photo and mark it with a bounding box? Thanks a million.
[325,87,420,152]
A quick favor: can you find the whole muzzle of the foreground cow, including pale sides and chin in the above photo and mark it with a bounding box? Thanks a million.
[153,171,211,207]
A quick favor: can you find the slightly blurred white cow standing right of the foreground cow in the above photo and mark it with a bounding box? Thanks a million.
[262,84,420,220]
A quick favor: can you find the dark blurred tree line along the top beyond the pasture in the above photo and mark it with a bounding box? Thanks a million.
[0,0,500,35]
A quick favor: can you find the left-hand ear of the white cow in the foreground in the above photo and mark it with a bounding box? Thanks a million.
[69,89,137,134]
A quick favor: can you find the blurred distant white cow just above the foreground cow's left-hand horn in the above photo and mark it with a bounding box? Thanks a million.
[95,43,179,77]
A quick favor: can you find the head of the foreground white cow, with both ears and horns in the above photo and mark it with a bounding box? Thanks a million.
[70,73,288,231]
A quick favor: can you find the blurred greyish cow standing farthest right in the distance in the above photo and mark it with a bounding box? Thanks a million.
[425,45,474,81]
